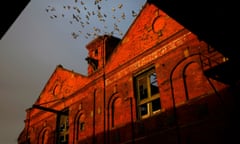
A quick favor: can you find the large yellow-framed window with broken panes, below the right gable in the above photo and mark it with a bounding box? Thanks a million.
[135,68,161,119]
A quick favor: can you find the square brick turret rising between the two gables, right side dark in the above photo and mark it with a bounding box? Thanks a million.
[85,35,121,75]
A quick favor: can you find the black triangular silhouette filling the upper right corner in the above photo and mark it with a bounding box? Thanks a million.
[148,0,240,62]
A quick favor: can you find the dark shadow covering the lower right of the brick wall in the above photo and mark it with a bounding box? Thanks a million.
[78,86,239,144]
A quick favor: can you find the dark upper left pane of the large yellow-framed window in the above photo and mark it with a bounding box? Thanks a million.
[138,77,148,101]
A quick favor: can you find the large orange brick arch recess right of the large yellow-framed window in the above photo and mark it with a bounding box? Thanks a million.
[170,54,218,105]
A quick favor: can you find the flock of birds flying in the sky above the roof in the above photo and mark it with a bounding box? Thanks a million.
[45,0,141,39]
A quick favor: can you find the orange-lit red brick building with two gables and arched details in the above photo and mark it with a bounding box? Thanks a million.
[18,2,239,144]
